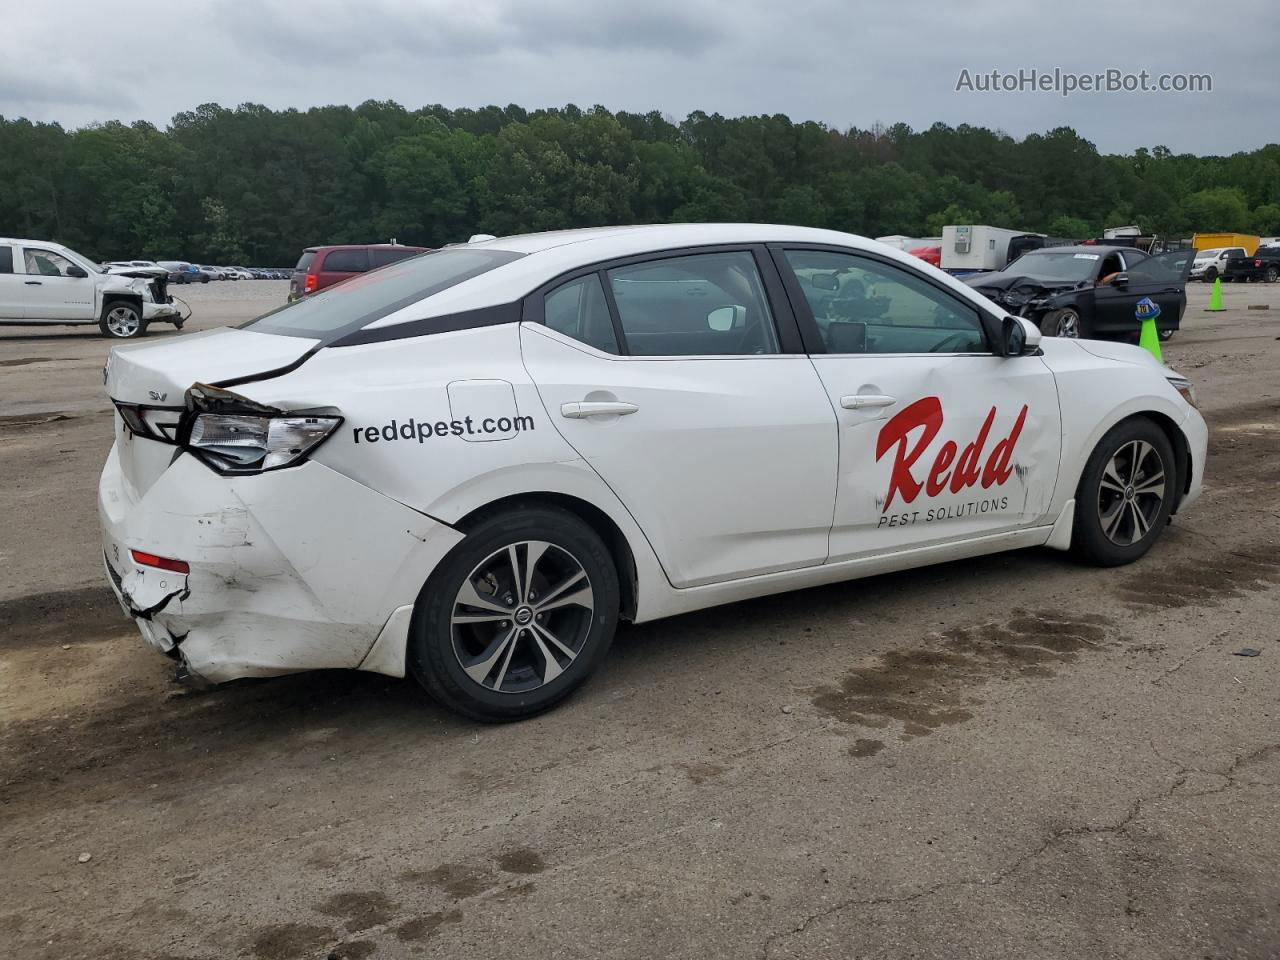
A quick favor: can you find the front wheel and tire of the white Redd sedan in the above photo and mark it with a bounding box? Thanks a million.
[1071,417,1179,567]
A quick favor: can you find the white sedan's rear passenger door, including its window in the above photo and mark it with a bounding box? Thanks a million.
[521,247,837,588]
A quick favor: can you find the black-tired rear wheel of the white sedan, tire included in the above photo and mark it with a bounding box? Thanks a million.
[407,504,618,723]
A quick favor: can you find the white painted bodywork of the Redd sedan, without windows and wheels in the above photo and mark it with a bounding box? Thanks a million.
[99,224,1207,681]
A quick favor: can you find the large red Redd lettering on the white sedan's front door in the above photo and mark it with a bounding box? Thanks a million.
[876,397,1027,512]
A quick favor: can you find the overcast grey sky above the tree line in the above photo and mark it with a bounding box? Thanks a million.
[0,0,1280,154]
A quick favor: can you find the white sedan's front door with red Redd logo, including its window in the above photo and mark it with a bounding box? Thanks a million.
[774,244,1061,562]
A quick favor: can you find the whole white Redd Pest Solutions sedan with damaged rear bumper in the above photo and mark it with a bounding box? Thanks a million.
[99,224,1207,721]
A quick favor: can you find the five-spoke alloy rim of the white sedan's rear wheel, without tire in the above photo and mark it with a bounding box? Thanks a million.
[449,540,595,694]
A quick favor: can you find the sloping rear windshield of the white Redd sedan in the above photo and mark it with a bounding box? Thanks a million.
[242,248,524,344]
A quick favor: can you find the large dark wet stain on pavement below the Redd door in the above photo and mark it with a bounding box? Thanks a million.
[813,611,1110,742]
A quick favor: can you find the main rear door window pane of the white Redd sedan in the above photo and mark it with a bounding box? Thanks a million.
[608,251,778,357]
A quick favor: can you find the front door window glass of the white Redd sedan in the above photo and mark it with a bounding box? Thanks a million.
[786,250,988,353]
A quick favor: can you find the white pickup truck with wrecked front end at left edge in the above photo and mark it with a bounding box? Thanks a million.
[0,237,186,339]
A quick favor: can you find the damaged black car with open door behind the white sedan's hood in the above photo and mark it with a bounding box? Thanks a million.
[963,244,1196,340]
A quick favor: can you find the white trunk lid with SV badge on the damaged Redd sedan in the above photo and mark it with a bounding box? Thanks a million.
[105,328,319,497]
